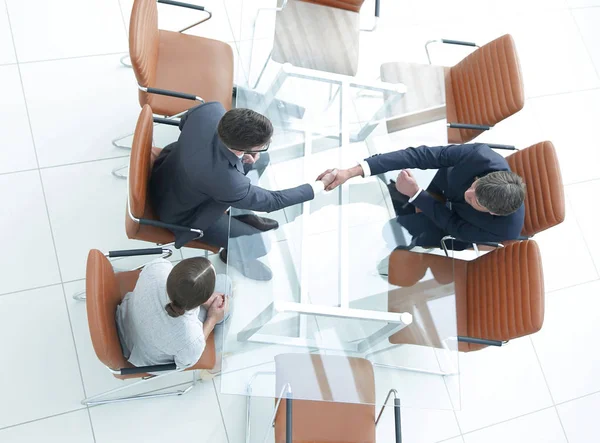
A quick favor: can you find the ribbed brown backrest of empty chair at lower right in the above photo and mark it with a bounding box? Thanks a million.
[466,240,544,351]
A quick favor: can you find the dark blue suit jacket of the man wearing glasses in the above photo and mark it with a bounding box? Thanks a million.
[150,102,314,248]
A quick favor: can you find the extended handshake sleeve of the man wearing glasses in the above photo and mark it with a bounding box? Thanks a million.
[217,180,315,212]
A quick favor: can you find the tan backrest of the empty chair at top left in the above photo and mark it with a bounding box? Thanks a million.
[129,0,159,87]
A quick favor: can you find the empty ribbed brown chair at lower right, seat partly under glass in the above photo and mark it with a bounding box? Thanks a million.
[388,240,544,352]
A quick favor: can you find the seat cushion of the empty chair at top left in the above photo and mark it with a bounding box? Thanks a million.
[140,30,233,115]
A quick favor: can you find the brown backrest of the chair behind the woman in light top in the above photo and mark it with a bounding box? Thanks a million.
[85,249,131,369]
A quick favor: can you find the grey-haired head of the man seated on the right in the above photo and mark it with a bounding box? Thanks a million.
[465,171,525,215]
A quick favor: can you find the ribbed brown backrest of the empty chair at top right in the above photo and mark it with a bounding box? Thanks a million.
[446,34,525,143]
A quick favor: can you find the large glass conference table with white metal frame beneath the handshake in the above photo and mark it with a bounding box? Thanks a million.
[220,0,460,420]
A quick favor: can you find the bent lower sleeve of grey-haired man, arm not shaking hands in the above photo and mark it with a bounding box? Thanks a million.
[413,192,505,243]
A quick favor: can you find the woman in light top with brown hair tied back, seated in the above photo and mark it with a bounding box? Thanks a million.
[116,257,231,369]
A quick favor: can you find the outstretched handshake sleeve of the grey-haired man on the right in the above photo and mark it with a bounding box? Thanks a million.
[365,144,478,175]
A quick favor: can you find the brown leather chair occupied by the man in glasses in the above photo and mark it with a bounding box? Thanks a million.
[125,105,220,253]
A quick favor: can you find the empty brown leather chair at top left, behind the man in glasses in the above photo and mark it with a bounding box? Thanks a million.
[129,0,233,116]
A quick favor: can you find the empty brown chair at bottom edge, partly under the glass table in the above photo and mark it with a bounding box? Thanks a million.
[247,354,401,443]
